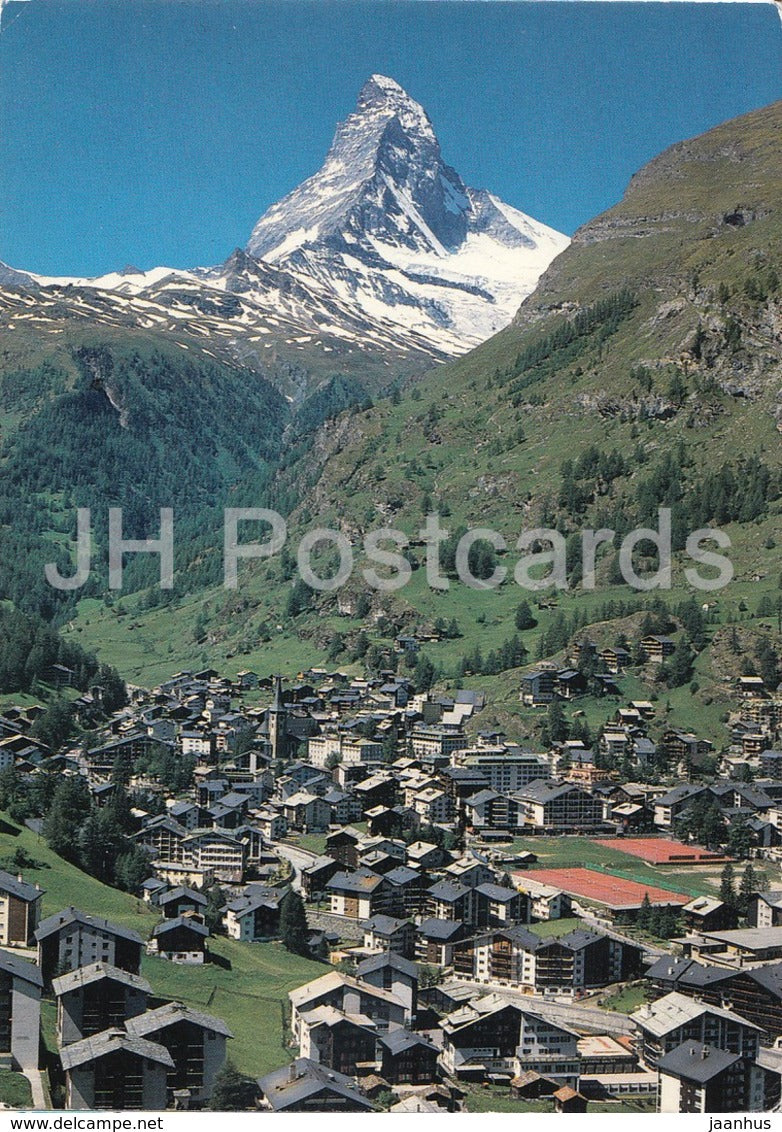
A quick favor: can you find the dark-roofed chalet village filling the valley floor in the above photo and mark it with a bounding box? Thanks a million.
[0,634,782,1113]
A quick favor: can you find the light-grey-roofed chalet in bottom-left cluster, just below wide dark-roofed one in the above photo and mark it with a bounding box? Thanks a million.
[52,963,152,1046]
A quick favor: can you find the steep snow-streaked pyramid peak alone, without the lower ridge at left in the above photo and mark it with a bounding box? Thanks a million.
[247,75,568,354]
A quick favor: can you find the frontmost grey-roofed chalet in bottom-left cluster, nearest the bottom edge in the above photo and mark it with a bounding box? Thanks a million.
[60,1029,174,1112]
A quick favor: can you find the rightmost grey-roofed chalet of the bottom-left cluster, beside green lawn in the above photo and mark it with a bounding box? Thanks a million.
[127,1002,233,1107]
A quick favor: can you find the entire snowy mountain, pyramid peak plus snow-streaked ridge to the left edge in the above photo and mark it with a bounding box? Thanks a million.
[0,75,568,384]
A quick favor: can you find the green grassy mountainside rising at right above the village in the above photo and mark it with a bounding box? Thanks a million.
[59,104,782,735]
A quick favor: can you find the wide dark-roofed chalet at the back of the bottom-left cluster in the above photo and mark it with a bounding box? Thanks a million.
[35,908,144,986]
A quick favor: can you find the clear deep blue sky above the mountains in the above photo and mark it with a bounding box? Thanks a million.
[0,0,782,274]
